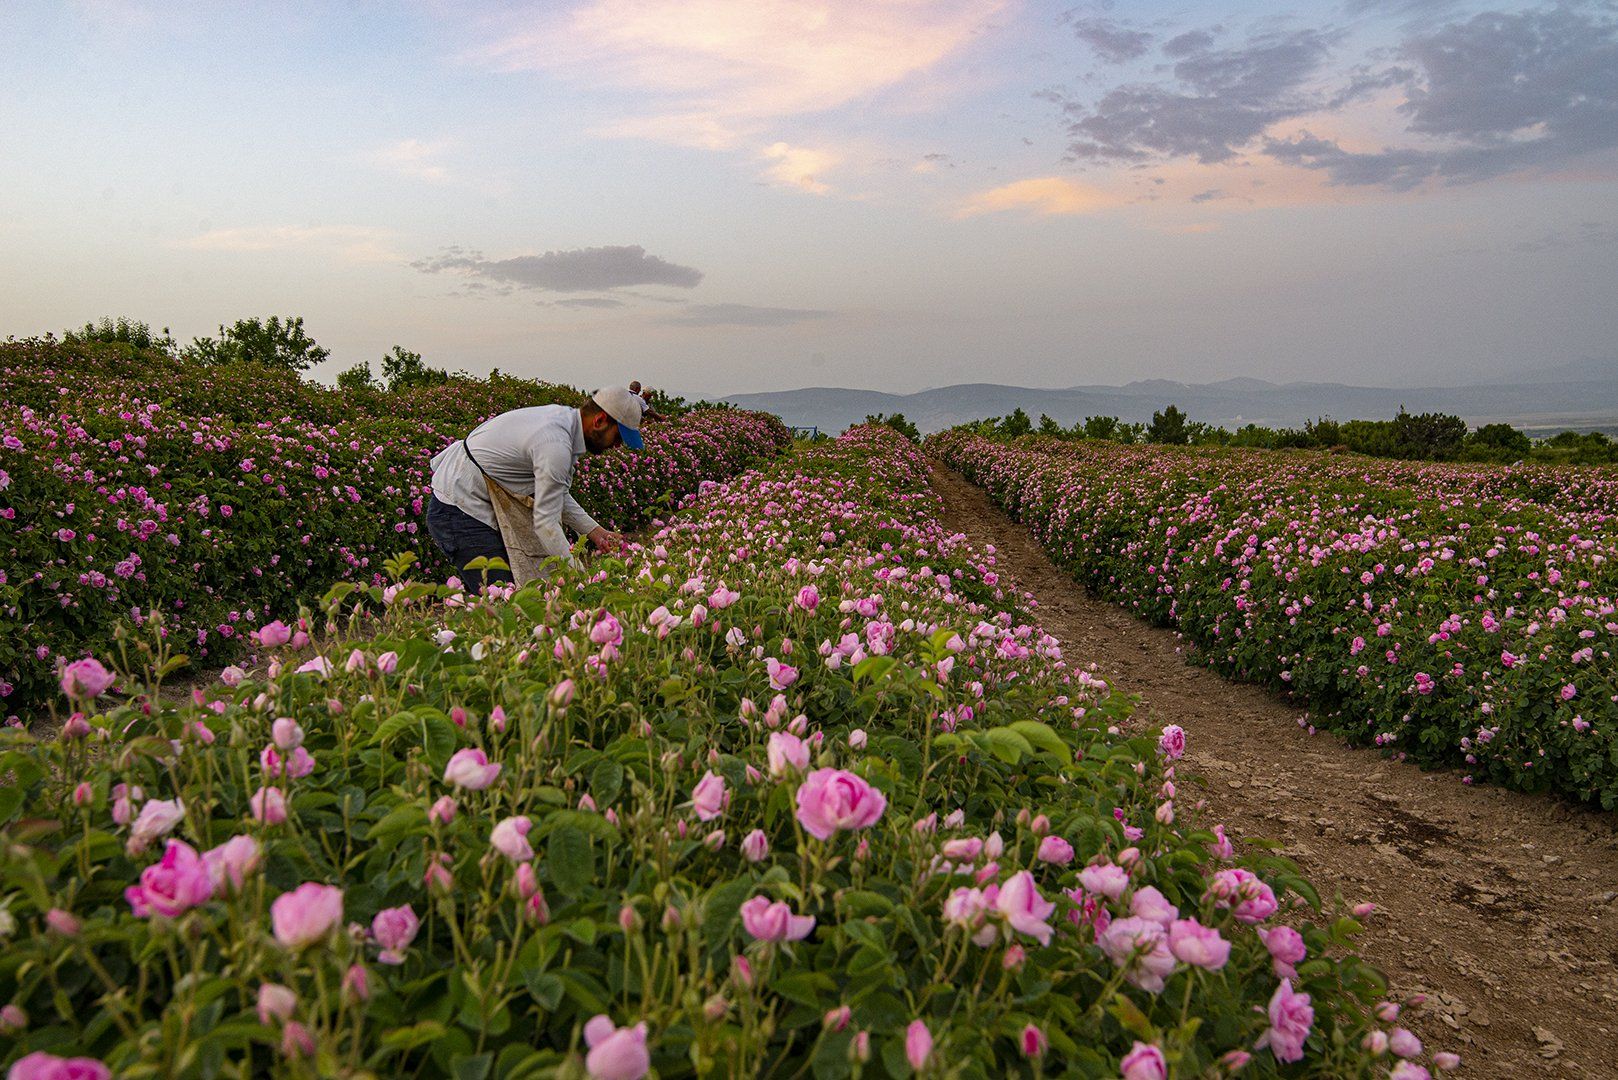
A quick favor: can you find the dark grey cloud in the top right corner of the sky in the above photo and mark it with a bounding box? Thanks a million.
[1265,6,1618,191]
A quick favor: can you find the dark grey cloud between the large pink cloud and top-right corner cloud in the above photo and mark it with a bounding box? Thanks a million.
[1063,29,1338,164]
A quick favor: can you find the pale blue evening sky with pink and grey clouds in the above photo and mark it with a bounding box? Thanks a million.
[0,0,1618,397]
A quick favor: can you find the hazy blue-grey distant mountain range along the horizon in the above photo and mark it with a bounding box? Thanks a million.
[725,358,1618,434]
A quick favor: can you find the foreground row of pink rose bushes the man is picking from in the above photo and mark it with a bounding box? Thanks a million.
[0,427,1449,1080]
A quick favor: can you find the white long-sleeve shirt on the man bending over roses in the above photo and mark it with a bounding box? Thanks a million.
[432,405,599,559]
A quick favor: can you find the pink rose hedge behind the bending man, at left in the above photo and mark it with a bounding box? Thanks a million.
[0,342,790,714]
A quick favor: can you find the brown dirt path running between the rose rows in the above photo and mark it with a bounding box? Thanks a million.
[934,466,1618,1077]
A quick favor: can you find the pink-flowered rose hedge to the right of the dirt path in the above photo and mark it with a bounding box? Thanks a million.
[929,432,1618,810]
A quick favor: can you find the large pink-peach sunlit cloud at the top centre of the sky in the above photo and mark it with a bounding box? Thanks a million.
[465,0,1006,147]
